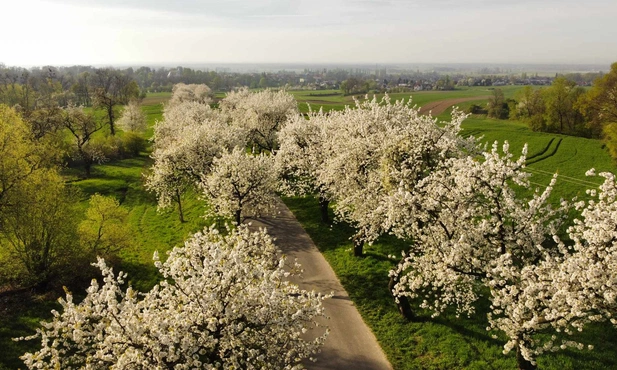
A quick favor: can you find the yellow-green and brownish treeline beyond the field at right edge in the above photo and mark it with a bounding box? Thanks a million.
[482,63,617,158]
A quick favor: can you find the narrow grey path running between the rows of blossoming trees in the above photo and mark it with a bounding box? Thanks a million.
[251,201,392,370]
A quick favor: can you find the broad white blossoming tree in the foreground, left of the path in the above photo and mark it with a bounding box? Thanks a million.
[21,227,328,369]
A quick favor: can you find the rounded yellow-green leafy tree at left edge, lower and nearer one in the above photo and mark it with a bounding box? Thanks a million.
[0,171,81,290]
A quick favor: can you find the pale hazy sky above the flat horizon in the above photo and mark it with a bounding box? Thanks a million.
[0,0,617,66]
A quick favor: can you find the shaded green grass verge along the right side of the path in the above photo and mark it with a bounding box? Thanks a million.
[284,197,617,370]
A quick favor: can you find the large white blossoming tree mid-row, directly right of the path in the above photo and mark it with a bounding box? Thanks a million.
[317,97,475,255]
